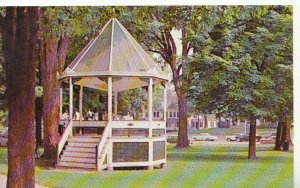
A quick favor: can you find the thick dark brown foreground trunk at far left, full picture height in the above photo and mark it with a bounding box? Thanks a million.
[3,7,38,187]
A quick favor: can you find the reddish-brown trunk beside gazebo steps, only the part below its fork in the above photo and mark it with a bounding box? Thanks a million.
[40,38,60,161]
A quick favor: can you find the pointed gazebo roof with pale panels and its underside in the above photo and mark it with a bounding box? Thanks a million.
[61,18,168,91]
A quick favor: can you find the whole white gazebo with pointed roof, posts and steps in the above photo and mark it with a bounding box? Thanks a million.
[57,18,168,170]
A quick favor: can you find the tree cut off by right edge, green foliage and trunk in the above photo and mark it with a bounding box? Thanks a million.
[253,6,293,150]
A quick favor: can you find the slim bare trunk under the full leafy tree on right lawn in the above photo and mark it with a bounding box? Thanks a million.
[248,115,256,159]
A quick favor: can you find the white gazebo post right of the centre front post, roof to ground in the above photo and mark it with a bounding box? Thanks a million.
[148,78,153,170]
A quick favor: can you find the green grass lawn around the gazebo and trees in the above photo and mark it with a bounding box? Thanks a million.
[0,144,293,188]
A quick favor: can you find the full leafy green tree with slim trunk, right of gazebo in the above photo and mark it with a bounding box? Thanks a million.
[189,6,291,159]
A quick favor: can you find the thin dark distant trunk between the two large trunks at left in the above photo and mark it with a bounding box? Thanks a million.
[35,97,43,145]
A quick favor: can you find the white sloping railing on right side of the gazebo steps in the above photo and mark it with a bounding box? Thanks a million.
[96,123,111,170]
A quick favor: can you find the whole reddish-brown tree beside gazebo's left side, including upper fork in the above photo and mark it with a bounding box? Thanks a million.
[39,8,68,161]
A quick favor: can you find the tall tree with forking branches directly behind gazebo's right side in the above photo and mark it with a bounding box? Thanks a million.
[122,6,206,148]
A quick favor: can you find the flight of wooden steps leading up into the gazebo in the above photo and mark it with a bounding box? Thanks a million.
[56,136,101,170]
